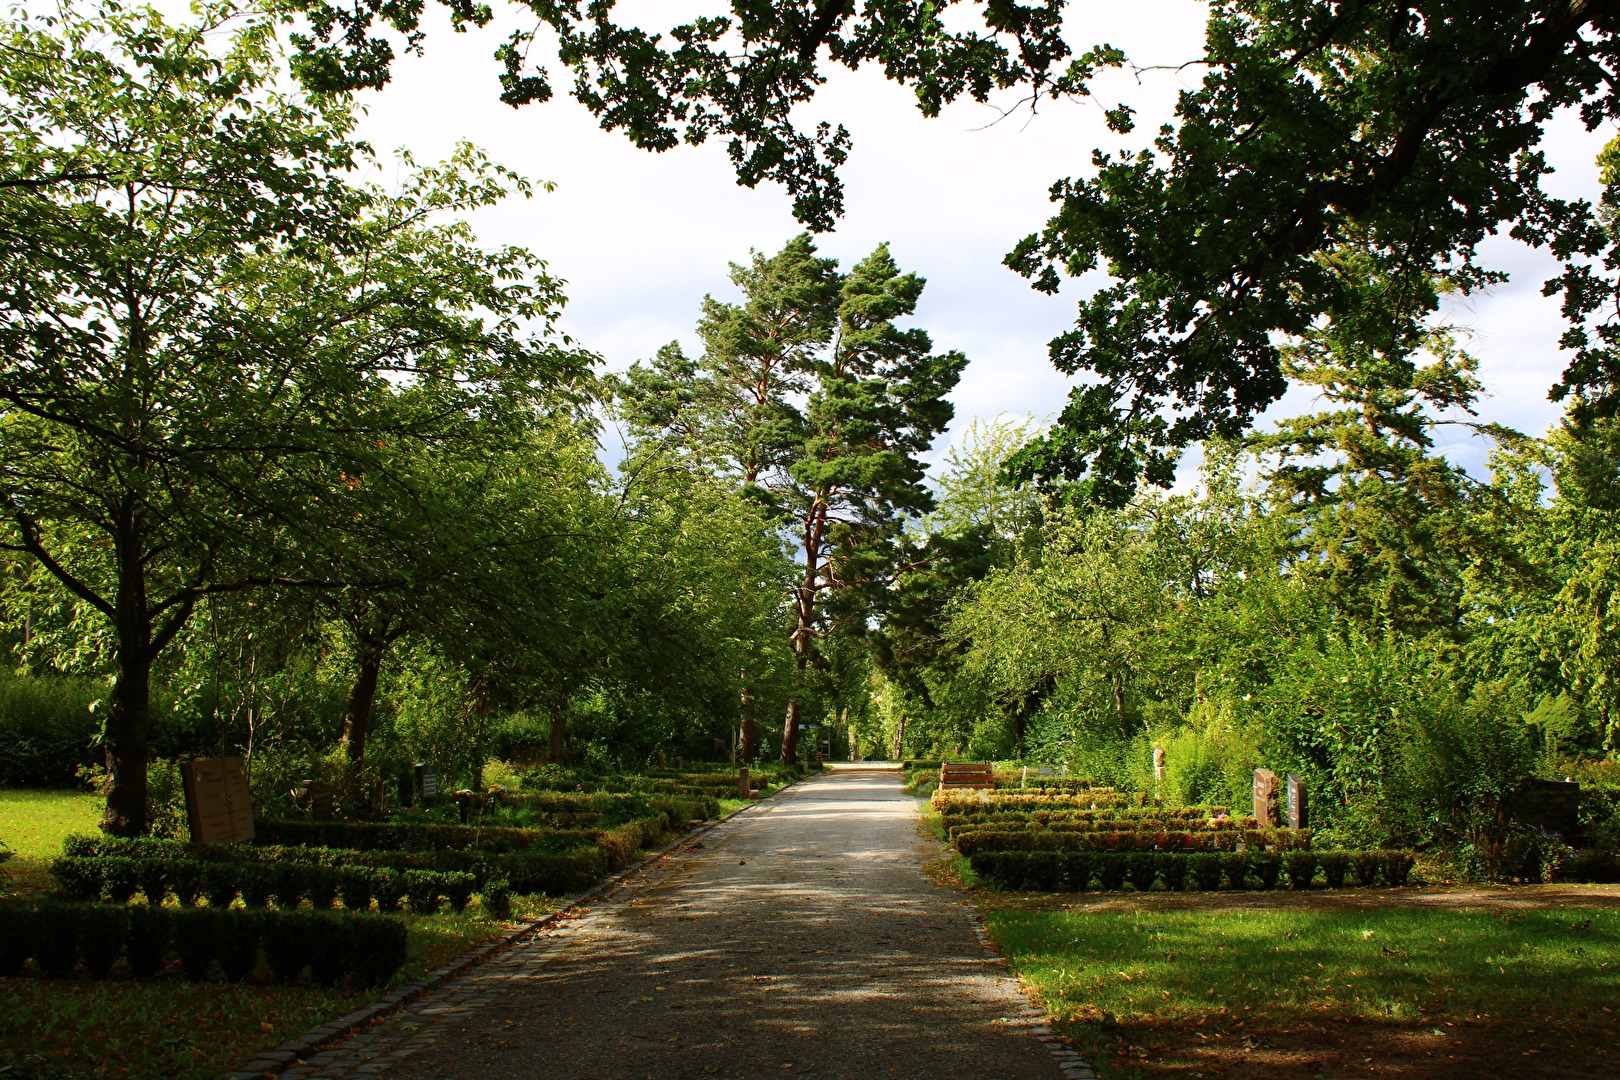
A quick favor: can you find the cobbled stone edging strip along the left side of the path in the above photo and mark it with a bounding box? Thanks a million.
[224,772,818,1080]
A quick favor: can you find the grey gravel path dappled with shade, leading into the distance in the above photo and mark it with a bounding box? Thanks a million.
[273,767,1090,1080]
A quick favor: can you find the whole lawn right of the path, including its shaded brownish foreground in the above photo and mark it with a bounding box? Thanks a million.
[985,897,1620,1078]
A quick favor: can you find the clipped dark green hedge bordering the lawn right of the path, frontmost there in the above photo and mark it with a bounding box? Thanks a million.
[969,852,1413,892]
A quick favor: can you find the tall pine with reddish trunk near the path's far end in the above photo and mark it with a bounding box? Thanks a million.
[629,236,967,761]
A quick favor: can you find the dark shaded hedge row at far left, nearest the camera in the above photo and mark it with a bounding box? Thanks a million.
[0,902,407,986]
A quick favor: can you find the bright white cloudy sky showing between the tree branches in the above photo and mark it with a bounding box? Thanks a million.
[345,0,1605,482]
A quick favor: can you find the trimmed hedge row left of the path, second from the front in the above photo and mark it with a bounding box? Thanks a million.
[50,855,480,915]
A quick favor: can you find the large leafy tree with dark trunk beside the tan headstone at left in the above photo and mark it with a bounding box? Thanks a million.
[0,8,575,836]
